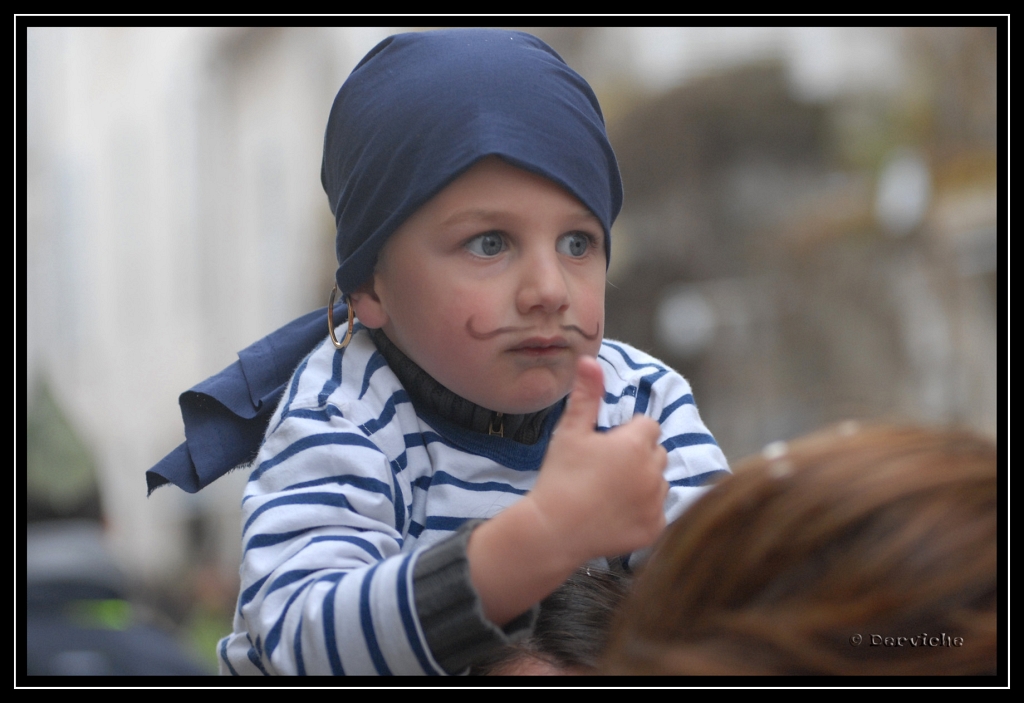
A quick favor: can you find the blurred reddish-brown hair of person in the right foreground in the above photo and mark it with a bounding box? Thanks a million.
[605,424,997,674]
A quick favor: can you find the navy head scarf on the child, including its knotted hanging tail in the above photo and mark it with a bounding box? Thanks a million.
[146,30,623,492]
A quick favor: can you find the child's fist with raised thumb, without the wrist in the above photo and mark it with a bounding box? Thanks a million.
[527,356,669,565]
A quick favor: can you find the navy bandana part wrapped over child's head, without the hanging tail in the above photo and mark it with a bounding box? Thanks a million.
[321,30,623,294]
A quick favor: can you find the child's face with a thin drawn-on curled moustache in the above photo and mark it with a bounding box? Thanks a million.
[352,158,605,413]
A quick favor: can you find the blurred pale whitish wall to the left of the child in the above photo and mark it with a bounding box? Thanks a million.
[26,28,397,579]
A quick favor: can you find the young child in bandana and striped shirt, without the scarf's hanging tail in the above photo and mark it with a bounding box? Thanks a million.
[219,30,728,674]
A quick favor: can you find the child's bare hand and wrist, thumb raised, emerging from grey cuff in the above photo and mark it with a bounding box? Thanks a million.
[466,356,669,625]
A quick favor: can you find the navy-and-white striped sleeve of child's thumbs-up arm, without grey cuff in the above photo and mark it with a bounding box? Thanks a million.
[220,408,443,675]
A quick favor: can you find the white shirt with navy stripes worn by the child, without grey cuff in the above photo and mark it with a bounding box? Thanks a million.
[218,329,728,675]
